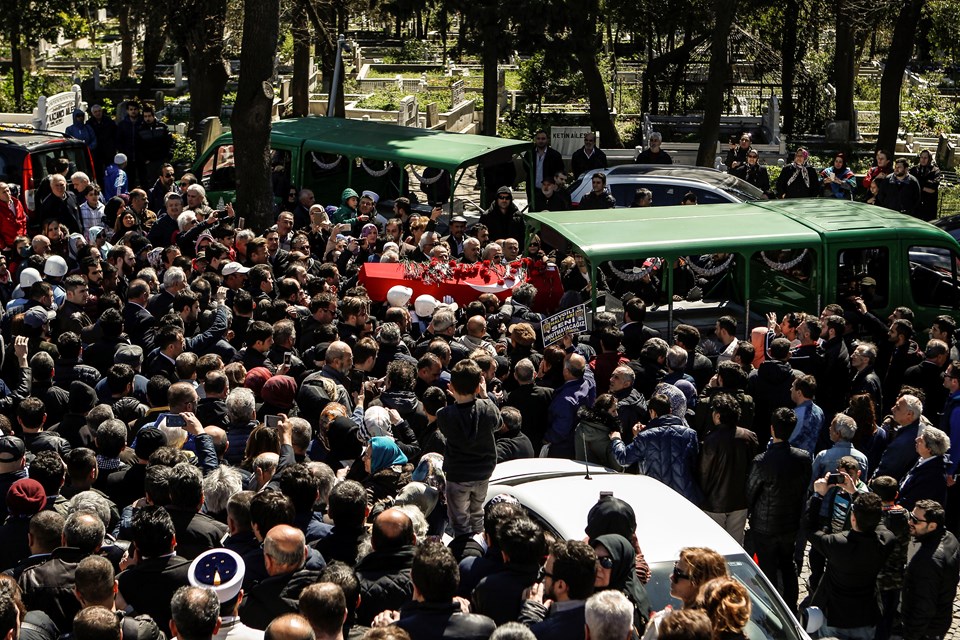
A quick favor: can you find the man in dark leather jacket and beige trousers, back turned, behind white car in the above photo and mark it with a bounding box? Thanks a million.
[698,393,757,544]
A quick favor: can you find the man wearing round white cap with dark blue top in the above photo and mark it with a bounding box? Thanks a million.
[187,549,263,640]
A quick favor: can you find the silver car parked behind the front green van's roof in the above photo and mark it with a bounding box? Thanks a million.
[570,164,763,207]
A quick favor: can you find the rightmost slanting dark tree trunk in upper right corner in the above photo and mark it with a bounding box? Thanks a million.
[877,0,926,152]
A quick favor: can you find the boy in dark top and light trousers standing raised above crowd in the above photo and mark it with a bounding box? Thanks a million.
[437,360,500,537]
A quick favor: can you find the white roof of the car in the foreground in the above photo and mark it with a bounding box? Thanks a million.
[487,459,744,564]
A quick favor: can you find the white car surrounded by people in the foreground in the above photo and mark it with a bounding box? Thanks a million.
[487,458,809,640]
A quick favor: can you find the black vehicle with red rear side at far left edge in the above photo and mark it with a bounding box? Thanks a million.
[0,127,96,217]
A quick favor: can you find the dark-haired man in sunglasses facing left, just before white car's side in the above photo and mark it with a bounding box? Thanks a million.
[519,540,597,640]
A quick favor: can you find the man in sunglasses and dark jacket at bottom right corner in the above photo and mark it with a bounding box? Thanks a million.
[900,500,960,640]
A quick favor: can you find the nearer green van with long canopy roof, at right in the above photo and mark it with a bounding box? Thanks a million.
[527,198,960,331]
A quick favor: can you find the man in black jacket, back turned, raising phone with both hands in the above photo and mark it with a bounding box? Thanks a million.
[807,490,896,638]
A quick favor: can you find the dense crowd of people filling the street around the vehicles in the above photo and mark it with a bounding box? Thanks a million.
[0,102,960,640]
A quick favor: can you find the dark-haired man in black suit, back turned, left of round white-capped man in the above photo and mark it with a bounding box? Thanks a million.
[117,505,190,629]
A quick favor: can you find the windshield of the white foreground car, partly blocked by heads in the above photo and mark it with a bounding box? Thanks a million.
[647,555,800,640]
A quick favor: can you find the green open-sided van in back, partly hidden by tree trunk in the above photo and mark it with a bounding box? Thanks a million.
[192,117,530,210]
